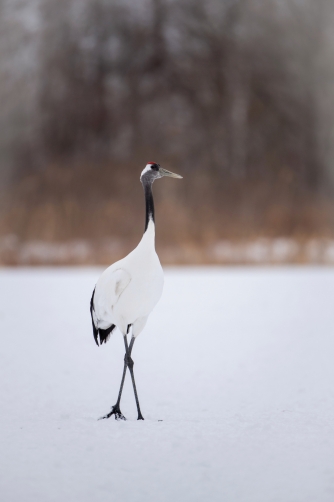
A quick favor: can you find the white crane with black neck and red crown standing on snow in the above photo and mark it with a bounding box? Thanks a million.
[90,162,182,420]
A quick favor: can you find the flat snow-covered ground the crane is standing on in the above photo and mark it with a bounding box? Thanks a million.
[0,268,334,502]
